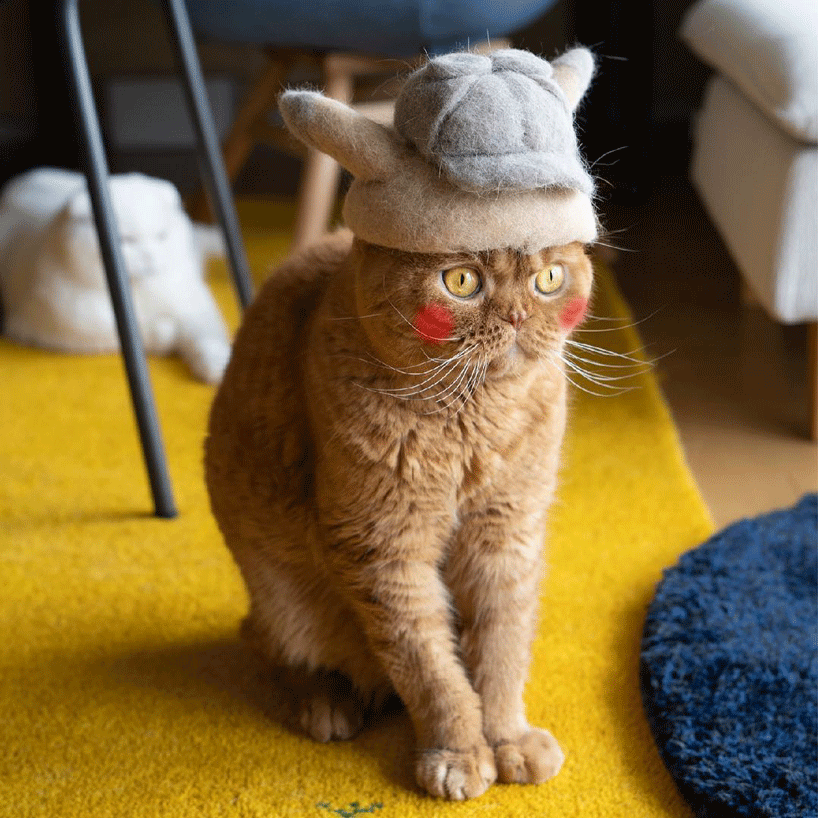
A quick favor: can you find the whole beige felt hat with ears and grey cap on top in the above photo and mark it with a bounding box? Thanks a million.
[279,48,597,253]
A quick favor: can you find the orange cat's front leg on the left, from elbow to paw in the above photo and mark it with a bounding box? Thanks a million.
[324,544,496,800]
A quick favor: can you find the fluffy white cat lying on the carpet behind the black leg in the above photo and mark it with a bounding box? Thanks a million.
[0,168,230,383]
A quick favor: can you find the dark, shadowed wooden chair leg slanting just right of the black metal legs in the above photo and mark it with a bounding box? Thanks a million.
[190,59,290,222]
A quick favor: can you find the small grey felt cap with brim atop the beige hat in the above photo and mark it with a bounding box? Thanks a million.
[395,49,594,196]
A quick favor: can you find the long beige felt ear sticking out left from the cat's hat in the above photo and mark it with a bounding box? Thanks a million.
[278,91,400,181]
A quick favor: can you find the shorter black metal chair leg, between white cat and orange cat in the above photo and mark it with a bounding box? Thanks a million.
[157,0,253,308]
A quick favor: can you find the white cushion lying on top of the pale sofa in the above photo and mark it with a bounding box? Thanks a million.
[680,0,818,144]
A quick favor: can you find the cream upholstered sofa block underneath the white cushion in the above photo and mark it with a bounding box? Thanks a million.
[691,76,818,324]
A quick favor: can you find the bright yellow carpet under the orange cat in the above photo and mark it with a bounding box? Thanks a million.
[0,199,711,818]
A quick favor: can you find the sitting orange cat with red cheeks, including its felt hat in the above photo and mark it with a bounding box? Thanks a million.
[205,44,596,799]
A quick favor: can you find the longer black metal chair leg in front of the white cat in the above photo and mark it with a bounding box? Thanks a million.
[58,0,177,518]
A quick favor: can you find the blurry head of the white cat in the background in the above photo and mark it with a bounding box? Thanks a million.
[56,173,201,286]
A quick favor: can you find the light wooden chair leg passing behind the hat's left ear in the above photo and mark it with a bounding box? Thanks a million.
[291,54,352,252]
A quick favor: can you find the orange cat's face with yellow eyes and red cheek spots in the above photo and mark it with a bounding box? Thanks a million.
[356,236,593,375]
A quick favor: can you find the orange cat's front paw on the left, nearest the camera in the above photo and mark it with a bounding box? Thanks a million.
[415,745,497,801]
